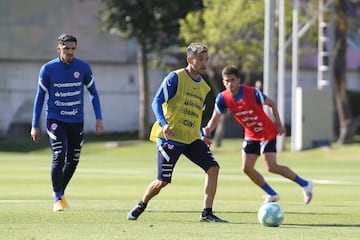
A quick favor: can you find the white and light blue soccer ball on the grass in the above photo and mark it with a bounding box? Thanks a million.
[258,202,284,227]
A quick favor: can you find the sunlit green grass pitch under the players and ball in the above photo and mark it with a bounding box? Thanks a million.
[0,138,360,240]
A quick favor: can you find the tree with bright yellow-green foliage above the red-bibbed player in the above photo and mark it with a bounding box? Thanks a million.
[180,0,291,146]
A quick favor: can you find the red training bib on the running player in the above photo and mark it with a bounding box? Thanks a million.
[221,86,278,141]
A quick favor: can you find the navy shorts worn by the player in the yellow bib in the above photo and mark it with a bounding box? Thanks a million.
[157,140,219,183]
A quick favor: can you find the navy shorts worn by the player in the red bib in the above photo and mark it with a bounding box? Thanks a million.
[243,138,276,155]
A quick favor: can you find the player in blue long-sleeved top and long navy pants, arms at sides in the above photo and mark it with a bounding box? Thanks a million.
[30,34,104,212]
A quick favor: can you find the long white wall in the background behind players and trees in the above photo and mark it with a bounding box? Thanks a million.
[0,61,360,137]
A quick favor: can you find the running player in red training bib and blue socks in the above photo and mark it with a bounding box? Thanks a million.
[203,66,312,204]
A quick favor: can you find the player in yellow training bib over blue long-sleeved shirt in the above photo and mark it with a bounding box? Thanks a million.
[128,43,225,222]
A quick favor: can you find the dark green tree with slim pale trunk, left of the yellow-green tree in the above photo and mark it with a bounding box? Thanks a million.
[100,0,203,140]
